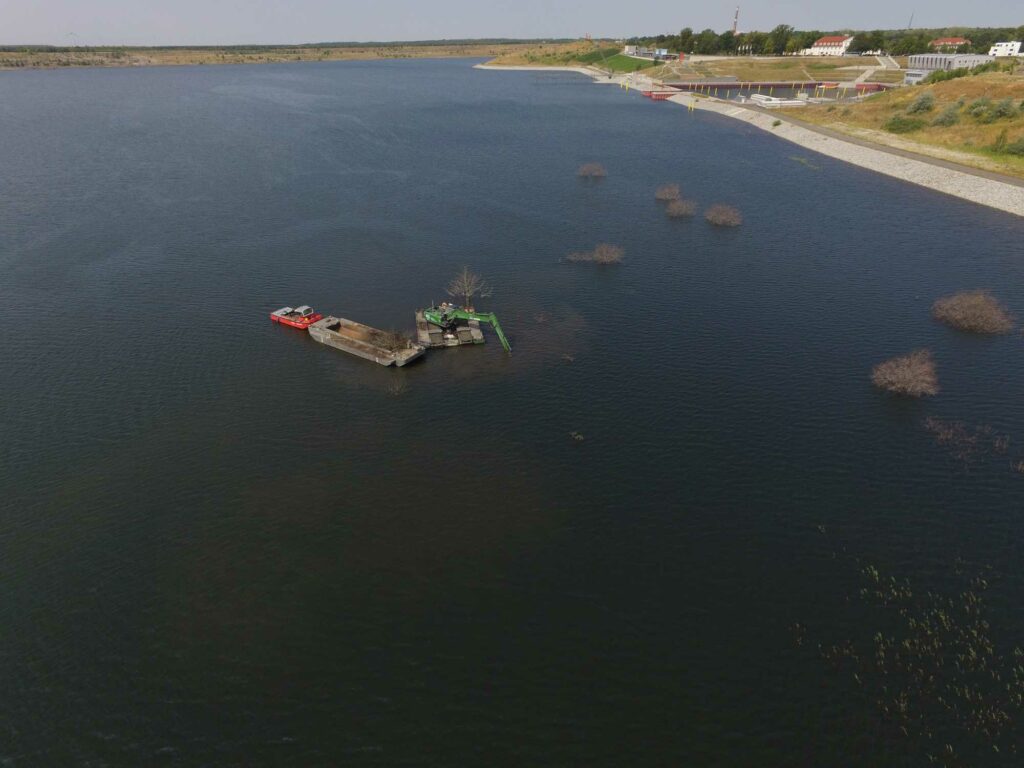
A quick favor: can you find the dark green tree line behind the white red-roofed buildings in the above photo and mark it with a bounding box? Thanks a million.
[629,24,1024,56]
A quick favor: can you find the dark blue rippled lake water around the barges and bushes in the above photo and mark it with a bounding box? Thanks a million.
[0,61,1024,766]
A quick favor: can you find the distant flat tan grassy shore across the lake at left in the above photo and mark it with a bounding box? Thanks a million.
[0,41,561,70]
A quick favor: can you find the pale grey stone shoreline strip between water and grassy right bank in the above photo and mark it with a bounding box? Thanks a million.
[476,65,1024,217]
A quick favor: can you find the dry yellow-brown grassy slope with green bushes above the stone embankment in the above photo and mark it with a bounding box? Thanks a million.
[784,72,1024,178]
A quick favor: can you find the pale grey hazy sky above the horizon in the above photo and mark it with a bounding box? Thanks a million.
[0,0,1024,45]
